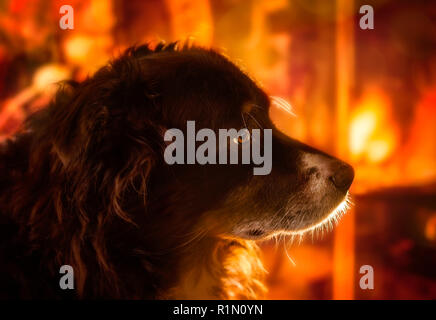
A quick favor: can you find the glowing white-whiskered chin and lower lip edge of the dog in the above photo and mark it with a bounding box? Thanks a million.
[238,193,351,240]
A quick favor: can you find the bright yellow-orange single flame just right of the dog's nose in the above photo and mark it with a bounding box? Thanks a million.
[348,87,402,193]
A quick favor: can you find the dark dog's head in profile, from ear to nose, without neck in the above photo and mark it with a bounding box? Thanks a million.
[43,44,354,244]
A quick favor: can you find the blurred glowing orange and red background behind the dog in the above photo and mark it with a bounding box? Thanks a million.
[0,0,436,299]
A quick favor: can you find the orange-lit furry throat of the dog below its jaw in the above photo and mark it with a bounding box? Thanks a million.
[163,238,266,299]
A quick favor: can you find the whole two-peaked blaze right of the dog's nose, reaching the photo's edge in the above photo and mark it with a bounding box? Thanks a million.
[348,87,436,193]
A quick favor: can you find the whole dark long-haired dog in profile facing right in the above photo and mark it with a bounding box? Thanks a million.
[0,43,354,299]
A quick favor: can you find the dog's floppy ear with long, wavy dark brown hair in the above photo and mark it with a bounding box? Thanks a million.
[22,56,163,295]
